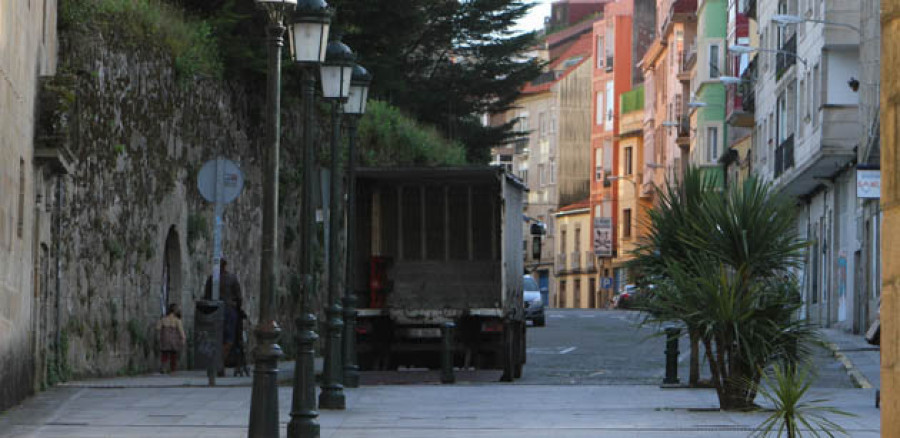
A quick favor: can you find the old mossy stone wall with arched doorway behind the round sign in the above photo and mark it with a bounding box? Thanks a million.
[41,27,308,376]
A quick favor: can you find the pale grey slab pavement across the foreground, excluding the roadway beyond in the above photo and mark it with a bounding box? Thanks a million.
[0,379,880,438]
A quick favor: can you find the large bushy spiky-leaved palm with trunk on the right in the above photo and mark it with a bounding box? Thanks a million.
[633,169,813,409]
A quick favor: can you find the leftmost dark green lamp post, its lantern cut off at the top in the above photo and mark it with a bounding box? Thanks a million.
[248,0,296,438]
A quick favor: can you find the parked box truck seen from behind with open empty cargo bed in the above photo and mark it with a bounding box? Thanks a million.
[352,167,525,379]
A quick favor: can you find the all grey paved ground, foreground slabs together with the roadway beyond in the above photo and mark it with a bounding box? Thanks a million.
[0,311,880,438]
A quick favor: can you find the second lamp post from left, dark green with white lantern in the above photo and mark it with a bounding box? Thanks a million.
[287,0,331,438]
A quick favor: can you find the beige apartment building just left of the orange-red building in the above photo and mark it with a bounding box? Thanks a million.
[492,33,591,304]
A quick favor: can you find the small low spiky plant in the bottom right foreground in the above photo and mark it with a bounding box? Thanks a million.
[752,363,852,438]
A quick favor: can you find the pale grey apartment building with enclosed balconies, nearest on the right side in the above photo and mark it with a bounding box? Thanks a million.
[740,0,880,331]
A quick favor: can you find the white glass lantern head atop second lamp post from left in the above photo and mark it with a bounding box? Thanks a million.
[290,0,331,64]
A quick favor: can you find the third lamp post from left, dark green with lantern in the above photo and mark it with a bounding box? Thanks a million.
[319,36,354,409]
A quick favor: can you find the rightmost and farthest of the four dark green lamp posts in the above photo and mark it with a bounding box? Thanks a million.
[343,64,372,388]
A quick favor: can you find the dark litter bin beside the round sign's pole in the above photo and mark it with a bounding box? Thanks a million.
[194,300,225,372]
